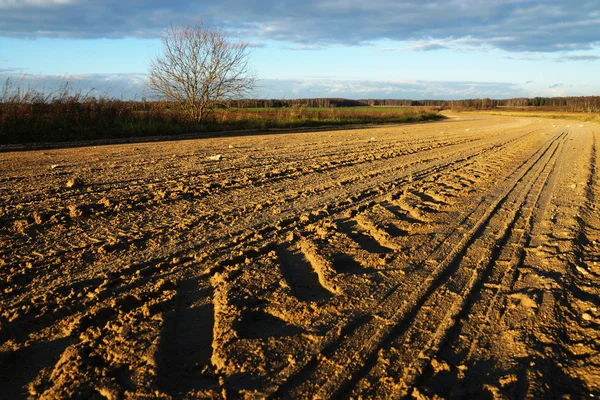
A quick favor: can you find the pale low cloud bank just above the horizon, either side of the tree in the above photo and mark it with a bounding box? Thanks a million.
[0,71,524,100]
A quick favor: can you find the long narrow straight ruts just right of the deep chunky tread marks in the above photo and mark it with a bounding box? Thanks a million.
[376,130,567,397]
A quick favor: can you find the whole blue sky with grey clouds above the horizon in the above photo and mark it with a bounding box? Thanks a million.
[0,0,600,99]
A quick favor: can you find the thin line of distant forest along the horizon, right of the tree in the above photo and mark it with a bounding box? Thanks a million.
[230,96,600,112]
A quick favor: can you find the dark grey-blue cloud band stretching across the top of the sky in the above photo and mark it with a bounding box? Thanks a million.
[0,0,600,52]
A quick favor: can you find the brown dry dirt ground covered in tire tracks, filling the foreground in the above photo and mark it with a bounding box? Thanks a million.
[0,114,600,399]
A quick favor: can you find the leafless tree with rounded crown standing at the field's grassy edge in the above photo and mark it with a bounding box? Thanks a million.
[148,22,255,123]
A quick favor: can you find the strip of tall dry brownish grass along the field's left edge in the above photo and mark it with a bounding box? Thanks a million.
[0,82,444,144]
